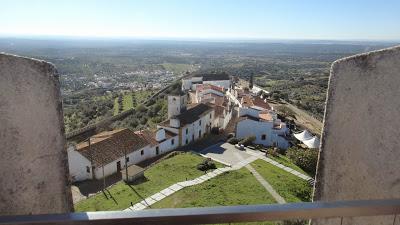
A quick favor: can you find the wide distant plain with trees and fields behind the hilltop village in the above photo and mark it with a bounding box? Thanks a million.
[0,38,396,133]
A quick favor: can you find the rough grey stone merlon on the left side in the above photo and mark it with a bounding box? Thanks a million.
[0,54,72,215]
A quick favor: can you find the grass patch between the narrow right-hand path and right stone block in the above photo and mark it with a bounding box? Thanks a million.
[251,159,311,202]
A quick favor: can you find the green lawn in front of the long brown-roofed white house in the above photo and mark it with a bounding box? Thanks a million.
[75,153,222,212]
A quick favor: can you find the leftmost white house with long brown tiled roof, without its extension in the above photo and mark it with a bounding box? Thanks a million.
[68,129,150,181]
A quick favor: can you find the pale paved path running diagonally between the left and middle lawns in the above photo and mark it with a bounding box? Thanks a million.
[124,156,257,211]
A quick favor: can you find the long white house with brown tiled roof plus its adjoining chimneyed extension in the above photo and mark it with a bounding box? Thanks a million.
[68,129,179,181]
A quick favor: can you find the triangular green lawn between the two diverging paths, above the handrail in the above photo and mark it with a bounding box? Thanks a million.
[152,168,275,208]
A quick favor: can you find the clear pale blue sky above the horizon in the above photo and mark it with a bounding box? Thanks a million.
[0,0,400,40]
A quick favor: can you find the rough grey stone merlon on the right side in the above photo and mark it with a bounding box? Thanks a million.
[314,47,400,225]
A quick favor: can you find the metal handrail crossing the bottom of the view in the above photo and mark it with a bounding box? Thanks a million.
[0,199,400,225]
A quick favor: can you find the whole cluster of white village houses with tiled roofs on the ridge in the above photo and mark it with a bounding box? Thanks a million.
[68,73,319,182]
